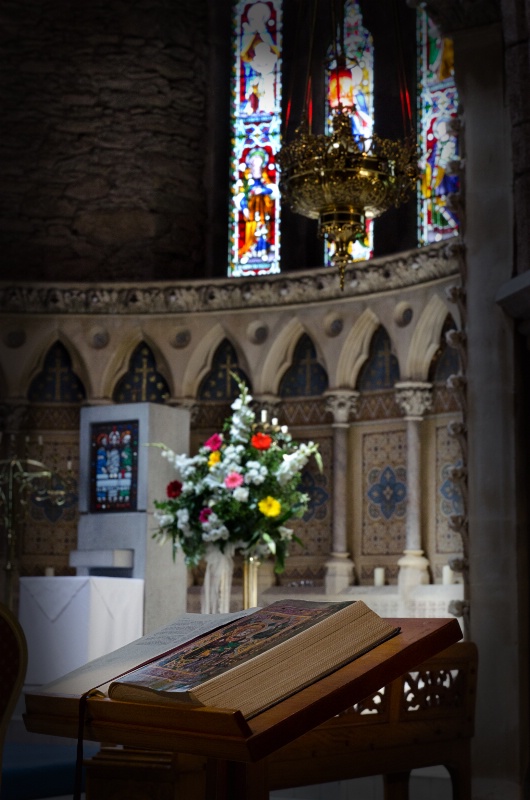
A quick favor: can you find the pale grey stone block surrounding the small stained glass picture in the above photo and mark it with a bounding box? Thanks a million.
[70,403,190,633]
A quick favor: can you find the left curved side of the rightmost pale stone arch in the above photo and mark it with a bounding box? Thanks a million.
[403,295,451,381]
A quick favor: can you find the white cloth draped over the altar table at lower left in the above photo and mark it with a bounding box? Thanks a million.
[19,576,144,685]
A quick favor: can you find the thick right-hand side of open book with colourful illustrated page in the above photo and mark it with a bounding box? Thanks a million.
[108,600,399,718]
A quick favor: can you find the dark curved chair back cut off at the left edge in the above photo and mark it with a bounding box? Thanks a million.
[0,603,28,784]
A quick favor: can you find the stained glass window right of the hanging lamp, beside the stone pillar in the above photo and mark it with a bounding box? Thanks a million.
[418,11,459,244]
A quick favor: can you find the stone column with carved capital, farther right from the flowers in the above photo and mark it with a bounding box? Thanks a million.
[395,381,432,592]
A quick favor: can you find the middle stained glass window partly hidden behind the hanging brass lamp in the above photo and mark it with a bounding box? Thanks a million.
[325,0,374,264]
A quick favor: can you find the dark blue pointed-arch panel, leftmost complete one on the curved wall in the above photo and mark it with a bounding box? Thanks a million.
[28,342,86,403]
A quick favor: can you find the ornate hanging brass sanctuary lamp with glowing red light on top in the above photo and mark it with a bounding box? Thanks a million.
[278,0,419,289]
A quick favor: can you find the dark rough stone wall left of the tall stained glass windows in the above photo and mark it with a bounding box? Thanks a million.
[0,0,208,280]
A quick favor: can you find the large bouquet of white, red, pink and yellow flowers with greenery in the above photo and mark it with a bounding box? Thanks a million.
[154,376,322,572]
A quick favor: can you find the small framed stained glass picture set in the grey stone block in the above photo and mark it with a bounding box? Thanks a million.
[90,420,138,513]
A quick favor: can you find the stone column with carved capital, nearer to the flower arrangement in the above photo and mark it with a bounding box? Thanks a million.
[325,389,359,594]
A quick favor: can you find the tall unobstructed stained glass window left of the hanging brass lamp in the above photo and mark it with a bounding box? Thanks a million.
[228,0,282,277]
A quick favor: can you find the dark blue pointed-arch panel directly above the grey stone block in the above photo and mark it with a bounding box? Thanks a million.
[112,342,170,403]
